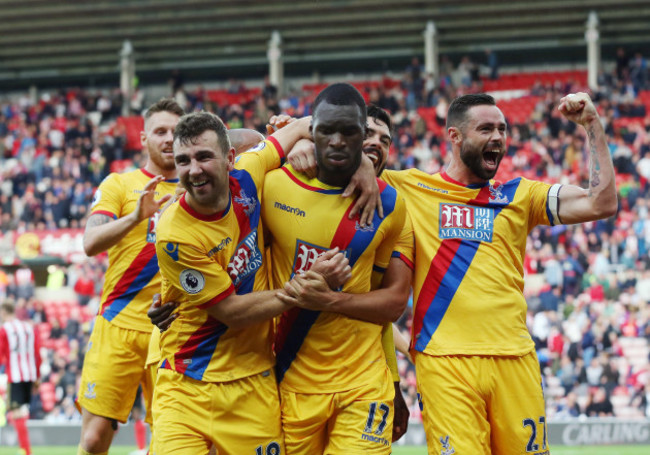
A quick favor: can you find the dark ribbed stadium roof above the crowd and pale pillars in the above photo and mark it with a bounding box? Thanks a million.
[0,0,650,87]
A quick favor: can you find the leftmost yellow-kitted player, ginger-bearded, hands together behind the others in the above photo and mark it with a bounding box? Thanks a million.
[77,99,184,454]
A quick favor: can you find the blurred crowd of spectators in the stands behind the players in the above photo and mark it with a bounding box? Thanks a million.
[0,50,650,421]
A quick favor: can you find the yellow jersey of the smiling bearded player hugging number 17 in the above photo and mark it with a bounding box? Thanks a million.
[156,139,284,382]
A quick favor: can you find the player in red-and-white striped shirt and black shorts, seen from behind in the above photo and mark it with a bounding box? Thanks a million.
[0,300,41,455]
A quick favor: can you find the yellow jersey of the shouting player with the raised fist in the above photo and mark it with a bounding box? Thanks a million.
[382,169,553,355]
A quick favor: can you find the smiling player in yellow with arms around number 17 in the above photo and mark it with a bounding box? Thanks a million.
[153,113,344,454]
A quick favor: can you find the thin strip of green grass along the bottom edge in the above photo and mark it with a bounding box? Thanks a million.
[0,446,648,455]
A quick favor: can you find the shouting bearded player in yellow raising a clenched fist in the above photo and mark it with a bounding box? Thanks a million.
[383,93,617,455]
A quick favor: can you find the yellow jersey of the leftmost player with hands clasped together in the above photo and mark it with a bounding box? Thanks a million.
[91,169,178,332]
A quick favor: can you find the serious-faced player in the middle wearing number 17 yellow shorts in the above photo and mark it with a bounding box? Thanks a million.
[262,84,409,454]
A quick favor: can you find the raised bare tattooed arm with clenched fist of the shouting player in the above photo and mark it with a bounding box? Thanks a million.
[549,93,618,224]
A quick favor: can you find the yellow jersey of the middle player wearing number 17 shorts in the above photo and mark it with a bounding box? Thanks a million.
[262,165,406,393]
